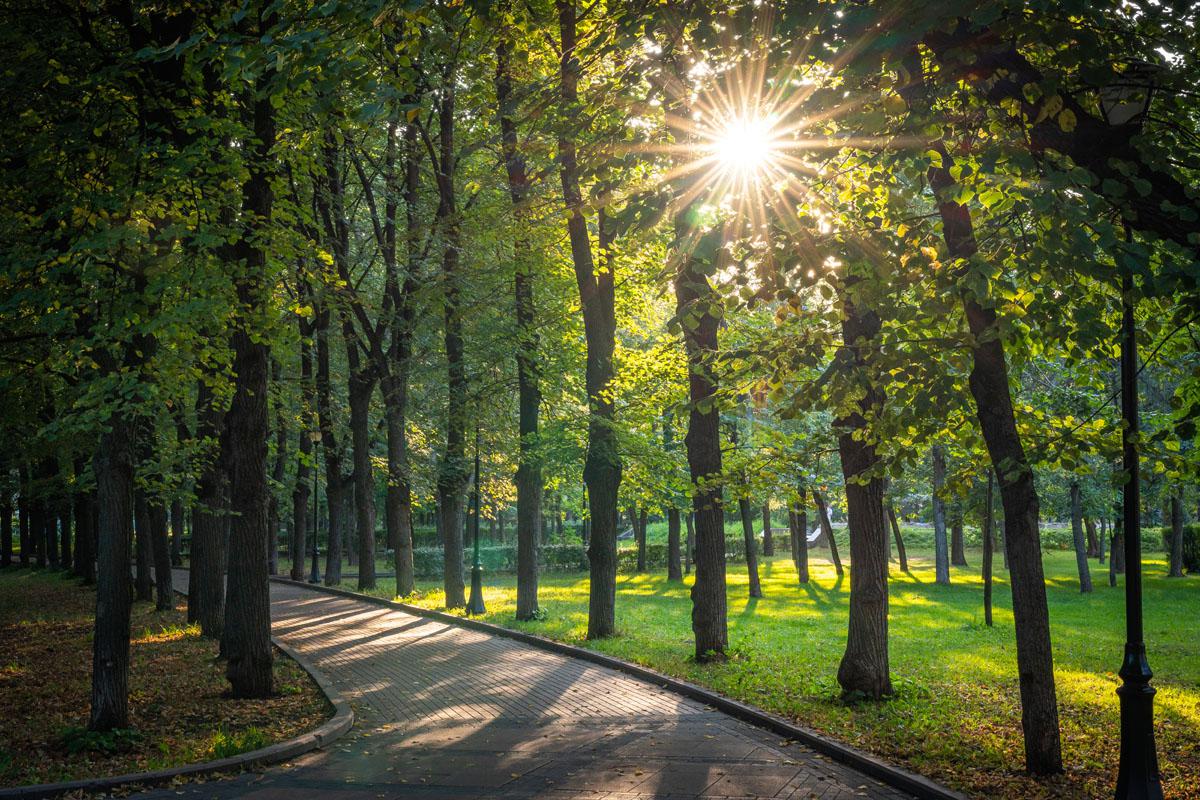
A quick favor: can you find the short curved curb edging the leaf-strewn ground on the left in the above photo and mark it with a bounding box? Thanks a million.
[0,637,354,800]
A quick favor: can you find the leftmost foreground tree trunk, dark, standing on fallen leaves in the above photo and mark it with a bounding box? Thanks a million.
[88,413,133,730]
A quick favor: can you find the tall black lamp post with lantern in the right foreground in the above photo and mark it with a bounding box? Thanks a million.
[1100,62,1163,800]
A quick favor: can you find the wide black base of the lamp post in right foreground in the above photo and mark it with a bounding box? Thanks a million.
[1116,644,1163,800]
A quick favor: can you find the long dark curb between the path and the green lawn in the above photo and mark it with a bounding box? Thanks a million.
[272,577,968,800]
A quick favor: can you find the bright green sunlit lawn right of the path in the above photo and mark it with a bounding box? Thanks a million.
[302,548,1200,799]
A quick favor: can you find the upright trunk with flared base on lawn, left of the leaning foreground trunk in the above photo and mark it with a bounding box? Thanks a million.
[829,289,892,699]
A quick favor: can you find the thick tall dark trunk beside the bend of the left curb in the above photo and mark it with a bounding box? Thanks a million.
[222,61,275,698]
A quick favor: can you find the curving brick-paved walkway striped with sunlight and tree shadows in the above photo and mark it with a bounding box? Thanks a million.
[147,572,908,800]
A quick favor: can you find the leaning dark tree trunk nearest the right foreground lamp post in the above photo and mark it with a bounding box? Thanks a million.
[913,133,1062,775]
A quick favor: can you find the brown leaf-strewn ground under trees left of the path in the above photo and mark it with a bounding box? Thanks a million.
[0,569,330,787]
